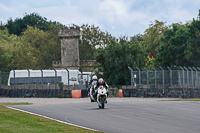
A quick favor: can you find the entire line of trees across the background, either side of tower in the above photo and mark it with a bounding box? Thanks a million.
[0,13,200,85]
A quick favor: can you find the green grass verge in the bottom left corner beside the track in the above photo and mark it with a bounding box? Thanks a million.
[0,103,100,133]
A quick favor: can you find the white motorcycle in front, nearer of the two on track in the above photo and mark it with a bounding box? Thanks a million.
[97,85,107,109]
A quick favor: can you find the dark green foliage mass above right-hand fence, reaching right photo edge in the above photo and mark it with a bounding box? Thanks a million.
[154,20,200,67]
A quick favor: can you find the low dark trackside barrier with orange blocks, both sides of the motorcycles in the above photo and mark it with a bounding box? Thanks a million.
[0,88,200,98]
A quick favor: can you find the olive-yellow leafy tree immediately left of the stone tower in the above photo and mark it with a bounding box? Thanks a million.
[12,26,60,69]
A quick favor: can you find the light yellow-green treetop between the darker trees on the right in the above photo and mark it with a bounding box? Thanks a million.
[141,20,167,58]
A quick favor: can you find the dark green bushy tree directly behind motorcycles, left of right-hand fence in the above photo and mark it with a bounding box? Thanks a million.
[96,38,145,85]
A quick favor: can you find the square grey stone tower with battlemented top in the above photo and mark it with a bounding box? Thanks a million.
[58,27,80,69]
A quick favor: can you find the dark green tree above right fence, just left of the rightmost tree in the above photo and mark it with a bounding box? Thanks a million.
[154,24,191,66]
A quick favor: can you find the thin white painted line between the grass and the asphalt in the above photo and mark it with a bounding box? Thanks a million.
[6,106,98,131]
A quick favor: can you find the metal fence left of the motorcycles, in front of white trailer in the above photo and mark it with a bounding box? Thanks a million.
[0,70,90,90]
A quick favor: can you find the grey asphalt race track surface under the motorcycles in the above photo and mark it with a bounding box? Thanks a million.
[9,99,200,133]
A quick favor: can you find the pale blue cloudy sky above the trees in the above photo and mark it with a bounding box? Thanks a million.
[0,0,200,37]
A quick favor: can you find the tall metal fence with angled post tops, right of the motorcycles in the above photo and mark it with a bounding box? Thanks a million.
[129,67,200,89]
